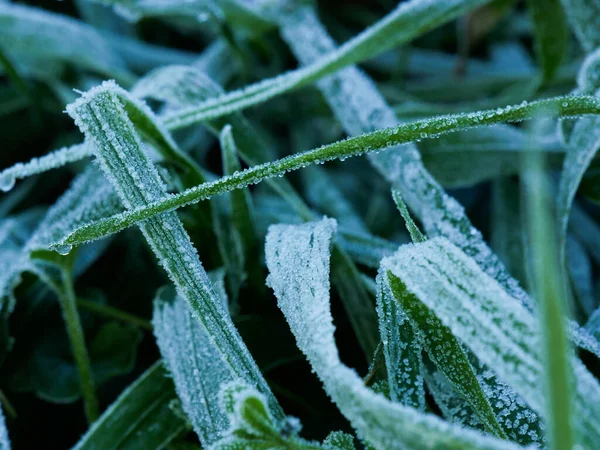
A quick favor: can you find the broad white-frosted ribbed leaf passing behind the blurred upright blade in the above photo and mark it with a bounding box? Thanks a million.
[382,238,600,447]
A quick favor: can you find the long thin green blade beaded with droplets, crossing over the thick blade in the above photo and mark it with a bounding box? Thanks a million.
[56,96,600,250]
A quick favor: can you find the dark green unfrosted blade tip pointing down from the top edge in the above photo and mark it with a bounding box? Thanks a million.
[527,0,568,82]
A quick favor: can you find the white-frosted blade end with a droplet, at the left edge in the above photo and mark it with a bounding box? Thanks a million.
[0,144,92,192]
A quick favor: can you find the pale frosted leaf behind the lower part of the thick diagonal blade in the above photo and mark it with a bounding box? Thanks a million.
[152,288,235,447]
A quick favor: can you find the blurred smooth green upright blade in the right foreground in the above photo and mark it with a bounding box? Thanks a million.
[523,149,576,450]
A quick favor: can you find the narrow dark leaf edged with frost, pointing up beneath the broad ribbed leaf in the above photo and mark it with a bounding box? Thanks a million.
[377,273,425,411]
